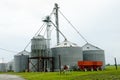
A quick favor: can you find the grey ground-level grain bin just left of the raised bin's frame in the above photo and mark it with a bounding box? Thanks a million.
[14,51,29,72]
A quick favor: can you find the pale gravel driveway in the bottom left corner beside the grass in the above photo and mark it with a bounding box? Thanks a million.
[0,74,25,80]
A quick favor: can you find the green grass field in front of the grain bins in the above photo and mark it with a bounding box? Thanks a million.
[3,66,120,80]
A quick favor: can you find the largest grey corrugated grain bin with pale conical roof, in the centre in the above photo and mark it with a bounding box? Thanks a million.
[52,40,83,71]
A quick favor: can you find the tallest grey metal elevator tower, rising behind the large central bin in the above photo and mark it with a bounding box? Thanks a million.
[54,3,60,45]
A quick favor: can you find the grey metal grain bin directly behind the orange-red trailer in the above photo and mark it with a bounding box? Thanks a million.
[82,43,105,69]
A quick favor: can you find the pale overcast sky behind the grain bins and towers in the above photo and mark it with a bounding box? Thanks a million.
[0,0,120,64]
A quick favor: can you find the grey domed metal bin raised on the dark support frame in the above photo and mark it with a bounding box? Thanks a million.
[31,35,47,57]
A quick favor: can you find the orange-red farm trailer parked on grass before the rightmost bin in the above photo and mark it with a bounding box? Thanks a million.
[78,61,103,71]
